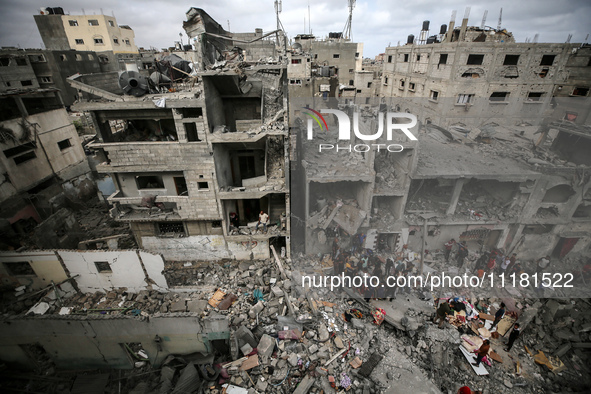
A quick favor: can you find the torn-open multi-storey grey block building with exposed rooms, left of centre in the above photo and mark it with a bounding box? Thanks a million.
[72,8,290,260]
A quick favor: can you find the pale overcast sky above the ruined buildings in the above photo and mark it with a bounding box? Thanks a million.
[0,0,591,57]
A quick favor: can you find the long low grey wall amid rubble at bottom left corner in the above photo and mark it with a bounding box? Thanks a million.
[0,314,229,369]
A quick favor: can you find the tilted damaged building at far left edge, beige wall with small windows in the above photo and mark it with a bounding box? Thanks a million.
[0,51,95,249]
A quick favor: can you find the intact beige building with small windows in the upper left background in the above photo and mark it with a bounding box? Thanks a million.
[35,14,138,54]
